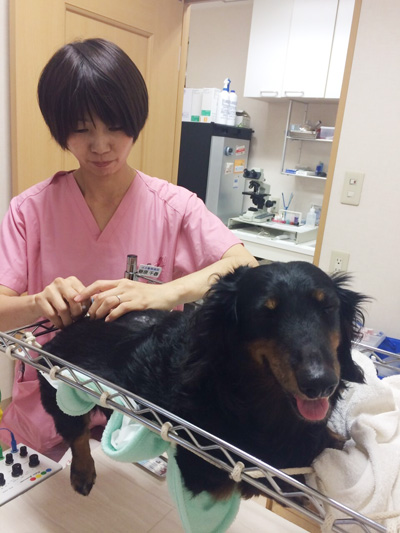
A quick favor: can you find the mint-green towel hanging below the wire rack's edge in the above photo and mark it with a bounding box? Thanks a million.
[57,375,240,533]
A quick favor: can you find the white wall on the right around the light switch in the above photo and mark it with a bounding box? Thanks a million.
[320,0,400,338]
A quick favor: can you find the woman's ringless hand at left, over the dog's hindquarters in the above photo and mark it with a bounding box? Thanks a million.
[34,276,90,328]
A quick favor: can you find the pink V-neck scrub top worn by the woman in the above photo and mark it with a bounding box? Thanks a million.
[0,172,240,453]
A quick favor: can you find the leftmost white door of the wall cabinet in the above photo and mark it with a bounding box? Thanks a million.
[244,0,292,97]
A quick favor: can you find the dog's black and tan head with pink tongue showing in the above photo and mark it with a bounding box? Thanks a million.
[192,262,366,421]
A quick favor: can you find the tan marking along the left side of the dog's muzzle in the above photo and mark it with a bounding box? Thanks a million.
[248,339,300,394]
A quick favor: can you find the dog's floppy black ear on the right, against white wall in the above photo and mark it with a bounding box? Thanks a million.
[332,272,370,383]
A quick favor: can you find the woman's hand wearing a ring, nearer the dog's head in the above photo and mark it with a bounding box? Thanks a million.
[74,278,177,322]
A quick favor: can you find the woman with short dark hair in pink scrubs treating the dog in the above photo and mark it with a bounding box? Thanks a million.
[0,39,257,453]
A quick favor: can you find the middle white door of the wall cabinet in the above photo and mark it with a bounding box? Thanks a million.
[282,0,338,98]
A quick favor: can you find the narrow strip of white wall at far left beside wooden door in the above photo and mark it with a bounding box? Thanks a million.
[0,0,13,400]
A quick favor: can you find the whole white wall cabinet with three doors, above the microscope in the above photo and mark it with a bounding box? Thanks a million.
[244,0,355,98]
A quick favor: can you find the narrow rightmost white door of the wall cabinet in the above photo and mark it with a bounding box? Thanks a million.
[325,0,355,98]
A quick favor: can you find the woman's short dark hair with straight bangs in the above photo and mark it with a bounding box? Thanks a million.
[38,39,148,149]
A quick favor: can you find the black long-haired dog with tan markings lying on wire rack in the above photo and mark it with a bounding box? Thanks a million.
[40,262,366,498]
